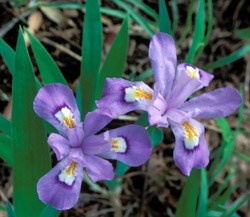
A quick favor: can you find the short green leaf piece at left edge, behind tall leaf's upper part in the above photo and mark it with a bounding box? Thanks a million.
[0,38,15,75]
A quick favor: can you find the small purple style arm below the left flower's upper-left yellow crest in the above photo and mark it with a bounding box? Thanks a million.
[67,123,84,147]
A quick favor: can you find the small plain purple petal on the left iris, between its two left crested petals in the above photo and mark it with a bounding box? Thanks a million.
[48,133,71,160]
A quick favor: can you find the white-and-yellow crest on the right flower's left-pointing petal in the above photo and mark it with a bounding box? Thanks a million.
[125,86,153,102]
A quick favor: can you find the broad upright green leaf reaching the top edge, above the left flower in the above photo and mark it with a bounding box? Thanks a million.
[80,0,102,117]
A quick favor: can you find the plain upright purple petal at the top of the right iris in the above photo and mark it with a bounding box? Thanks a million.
[149,32,176,98]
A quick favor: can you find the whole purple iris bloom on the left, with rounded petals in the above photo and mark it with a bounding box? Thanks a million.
[34,84,152,210]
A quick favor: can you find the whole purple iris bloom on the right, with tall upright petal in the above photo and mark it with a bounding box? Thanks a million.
[97,33,242,175]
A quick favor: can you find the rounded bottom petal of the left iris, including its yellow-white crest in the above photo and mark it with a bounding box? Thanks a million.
[37,159,83,210]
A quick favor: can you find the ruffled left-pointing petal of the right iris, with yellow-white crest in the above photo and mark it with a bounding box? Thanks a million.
[96,78,153,117]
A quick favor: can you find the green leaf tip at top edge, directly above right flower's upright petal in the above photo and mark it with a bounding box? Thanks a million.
[159,0,172,35]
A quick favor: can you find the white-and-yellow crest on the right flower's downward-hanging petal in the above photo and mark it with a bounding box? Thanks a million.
[182,121,200,149]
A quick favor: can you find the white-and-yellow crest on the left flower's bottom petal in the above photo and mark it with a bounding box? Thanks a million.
[58,162,77,185]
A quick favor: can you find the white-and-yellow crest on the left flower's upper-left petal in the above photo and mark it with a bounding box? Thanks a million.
[55,107,75,128]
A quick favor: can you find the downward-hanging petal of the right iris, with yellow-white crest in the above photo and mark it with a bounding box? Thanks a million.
[172,119,209,176]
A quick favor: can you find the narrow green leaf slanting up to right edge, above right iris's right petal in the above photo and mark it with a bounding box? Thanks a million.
[204,45,250,70]
